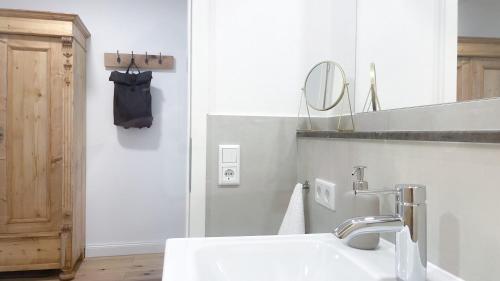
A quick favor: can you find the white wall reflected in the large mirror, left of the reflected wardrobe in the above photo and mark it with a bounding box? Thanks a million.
[356,0,457,112]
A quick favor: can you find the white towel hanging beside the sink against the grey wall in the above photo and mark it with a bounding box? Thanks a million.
[278,183,306,235]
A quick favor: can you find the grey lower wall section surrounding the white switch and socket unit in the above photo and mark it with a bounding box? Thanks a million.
[206,115,297,236]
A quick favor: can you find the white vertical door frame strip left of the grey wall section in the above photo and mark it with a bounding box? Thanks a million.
[186,0,212,237]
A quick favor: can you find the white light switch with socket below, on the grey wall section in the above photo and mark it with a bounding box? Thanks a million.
[219,145,240,186]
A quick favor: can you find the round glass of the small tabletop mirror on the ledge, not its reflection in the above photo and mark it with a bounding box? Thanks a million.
[304,61,346,111]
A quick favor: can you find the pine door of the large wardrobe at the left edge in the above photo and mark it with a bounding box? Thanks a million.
[0,36,62,233]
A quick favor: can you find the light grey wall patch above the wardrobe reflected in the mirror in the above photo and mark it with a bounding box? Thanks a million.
[458,0,500,38]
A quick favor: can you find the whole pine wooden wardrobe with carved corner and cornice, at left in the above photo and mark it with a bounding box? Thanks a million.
[0,9,90,280]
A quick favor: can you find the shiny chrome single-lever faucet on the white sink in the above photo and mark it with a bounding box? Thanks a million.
[333,172,427,281]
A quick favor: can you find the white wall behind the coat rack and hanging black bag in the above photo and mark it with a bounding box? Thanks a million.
[0,0,188,256]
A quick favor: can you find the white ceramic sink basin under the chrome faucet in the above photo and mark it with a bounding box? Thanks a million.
[163,234,460,281]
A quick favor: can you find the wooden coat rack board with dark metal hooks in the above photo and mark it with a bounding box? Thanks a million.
[104,52,174,69]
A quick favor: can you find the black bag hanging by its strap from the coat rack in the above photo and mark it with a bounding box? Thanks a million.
[109,58,153,129]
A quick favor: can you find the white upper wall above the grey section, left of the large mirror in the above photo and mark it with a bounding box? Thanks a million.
[209,0,356,116]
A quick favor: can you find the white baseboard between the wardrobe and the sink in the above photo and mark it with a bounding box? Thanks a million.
[85,241,165,257]
